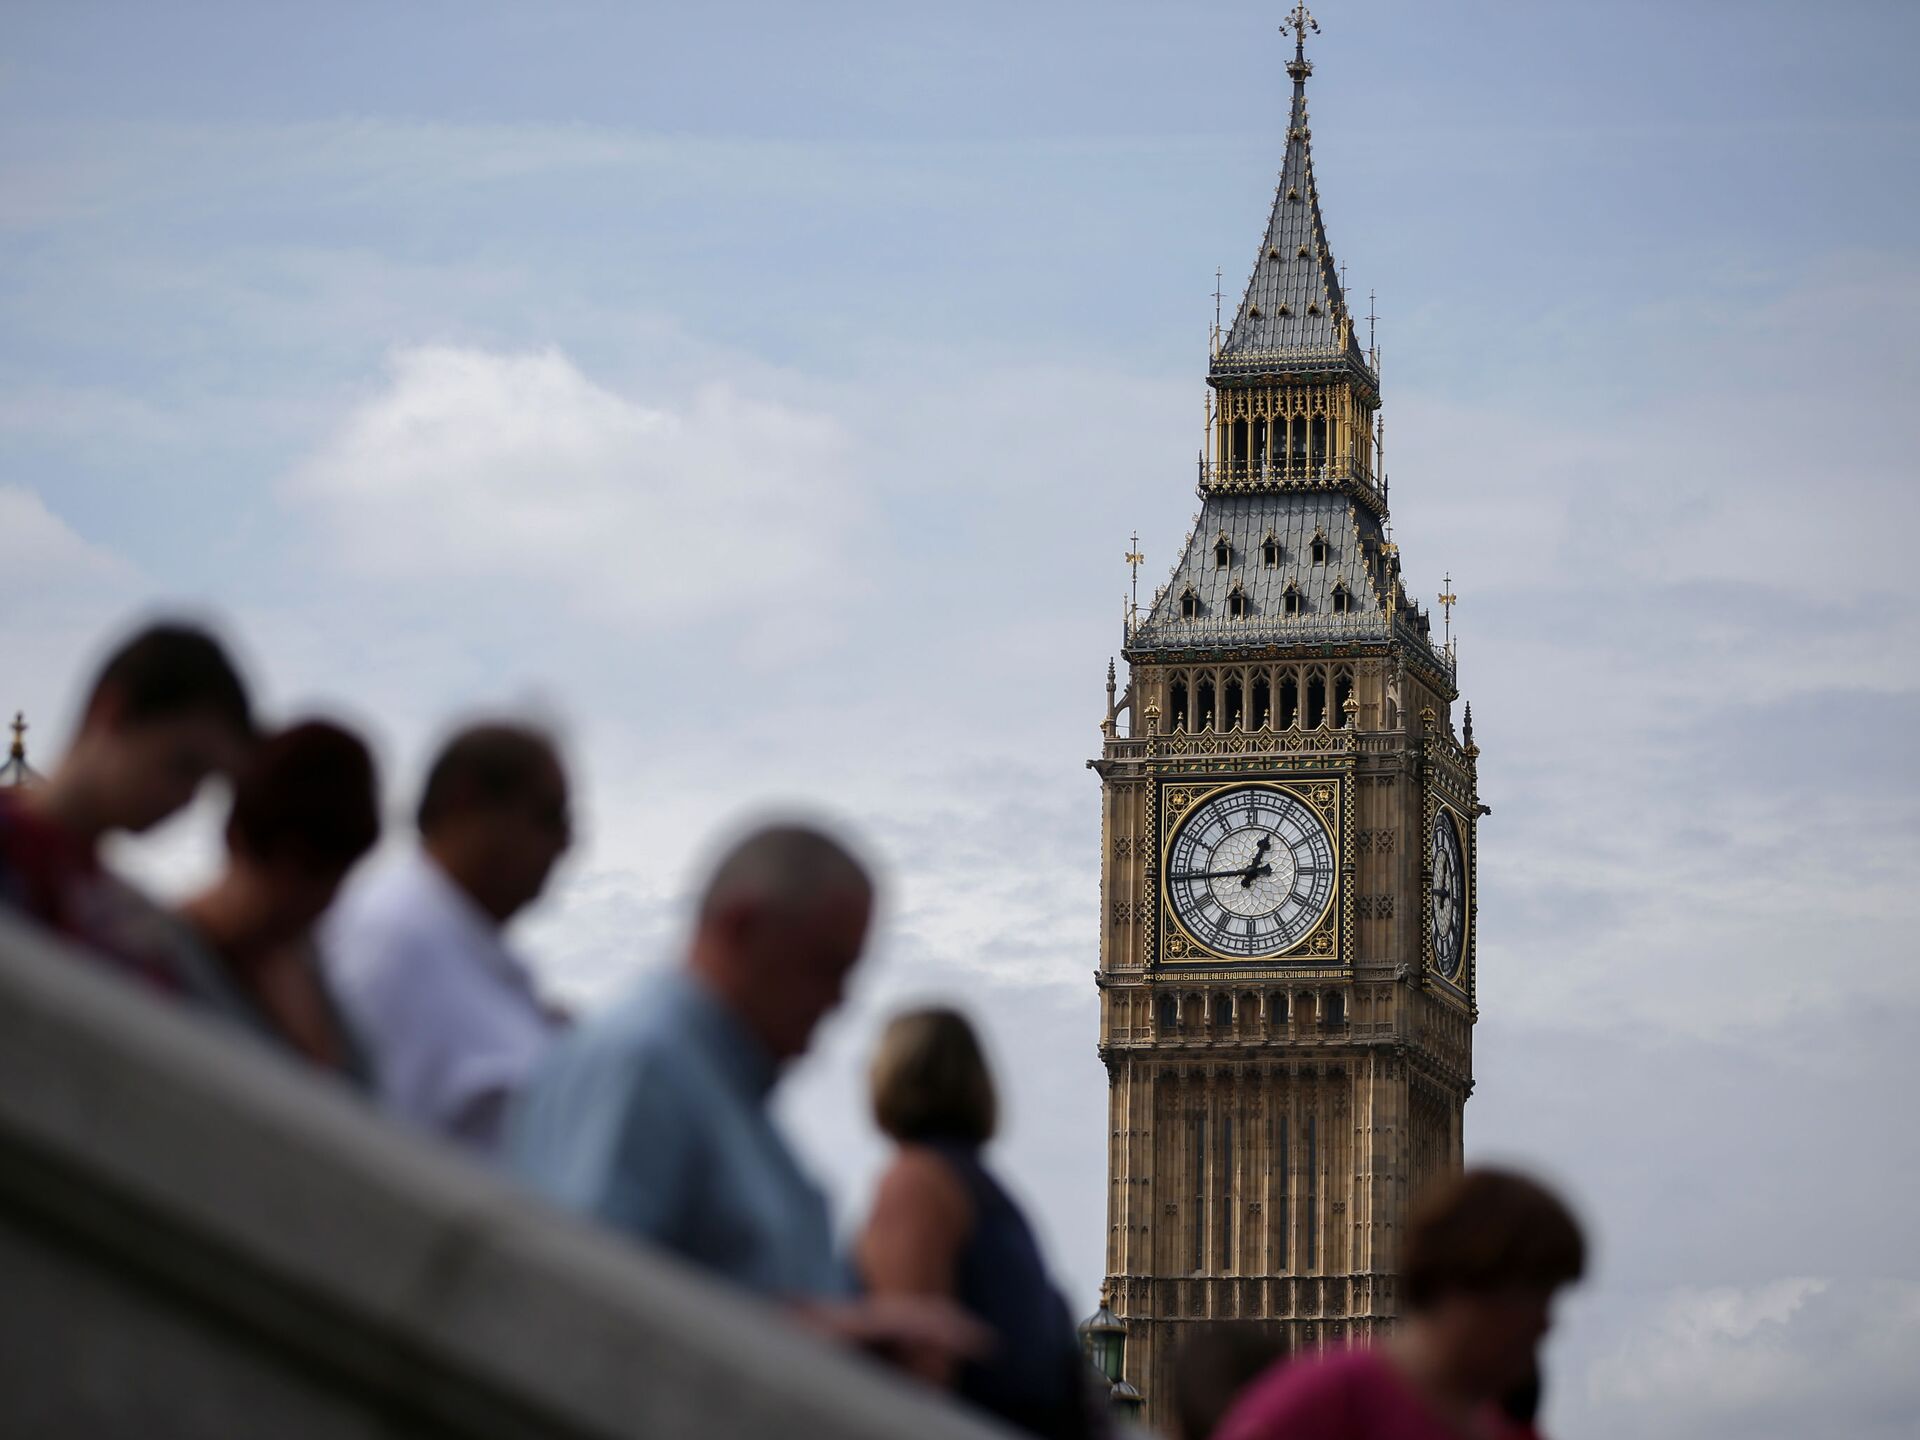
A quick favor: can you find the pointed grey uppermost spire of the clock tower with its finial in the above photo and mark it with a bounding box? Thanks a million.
[1213,4,1363,374]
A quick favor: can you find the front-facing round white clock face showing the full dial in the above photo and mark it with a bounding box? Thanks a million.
[1167,785,1334,956]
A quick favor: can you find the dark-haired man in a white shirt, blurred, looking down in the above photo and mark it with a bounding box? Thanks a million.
[321,724,572,1154]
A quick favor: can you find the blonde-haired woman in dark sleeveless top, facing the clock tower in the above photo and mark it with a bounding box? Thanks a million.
[854,1010,1092,1440]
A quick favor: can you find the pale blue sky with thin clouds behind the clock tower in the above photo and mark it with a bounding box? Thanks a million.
[0,0,1920,1440]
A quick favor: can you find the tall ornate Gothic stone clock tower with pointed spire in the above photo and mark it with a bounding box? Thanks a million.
[1091,6,1484,1423]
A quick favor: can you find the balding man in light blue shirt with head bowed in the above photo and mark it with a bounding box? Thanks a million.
[507,826,887,1305]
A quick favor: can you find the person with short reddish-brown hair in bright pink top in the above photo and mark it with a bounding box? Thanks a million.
[1213,1169,1586,1440]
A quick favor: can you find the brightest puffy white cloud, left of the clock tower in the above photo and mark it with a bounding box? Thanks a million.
[288,346,860,652]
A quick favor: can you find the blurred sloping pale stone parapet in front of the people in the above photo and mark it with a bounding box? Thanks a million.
[0,916,1004,1440]
